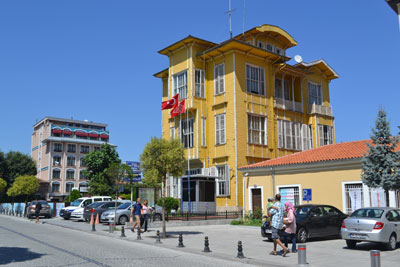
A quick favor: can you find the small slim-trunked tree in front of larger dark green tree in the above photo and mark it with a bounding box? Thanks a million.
[106,162,133,225]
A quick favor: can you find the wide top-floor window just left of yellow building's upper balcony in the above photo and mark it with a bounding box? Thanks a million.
[245,63,266,96]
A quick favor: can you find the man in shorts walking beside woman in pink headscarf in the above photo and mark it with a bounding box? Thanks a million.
[269,194,288,257]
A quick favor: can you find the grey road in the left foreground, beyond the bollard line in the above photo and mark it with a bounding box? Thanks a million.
[0,215,255,267]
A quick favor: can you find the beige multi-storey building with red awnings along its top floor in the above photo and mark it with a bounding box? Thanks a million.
[31,117,110,200]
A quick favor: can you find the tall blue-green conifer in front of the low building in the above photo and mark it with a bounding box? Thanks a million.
[361,108,400,207]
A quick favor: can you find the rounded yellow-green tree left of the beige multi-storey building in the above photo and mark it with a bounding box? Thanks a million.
[7,175,40,201]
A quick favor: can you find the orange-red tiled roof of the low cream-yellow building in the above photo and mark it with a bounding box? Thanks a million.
[240,140,376,169]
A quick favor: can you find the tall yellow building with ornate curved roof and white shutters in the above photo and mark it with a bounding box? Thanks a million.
[154,25,338,211]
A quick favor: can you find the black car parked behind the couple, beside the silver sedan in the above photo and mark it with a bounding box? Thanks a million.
[261,204,347,243]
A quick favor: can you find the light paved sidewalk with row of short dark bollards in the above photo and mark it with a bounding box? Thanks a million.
[3,218,400,267]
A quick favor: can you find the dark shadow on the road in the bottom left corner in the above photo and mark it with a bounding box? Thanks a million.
[0,247,46,265]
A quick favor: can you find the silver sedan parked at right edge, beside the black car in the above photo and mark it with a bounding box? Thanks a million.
[341,208,400,250]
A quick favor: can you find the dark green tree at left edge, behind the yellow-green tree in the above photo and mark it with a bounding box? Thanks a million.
[0,151,37,186]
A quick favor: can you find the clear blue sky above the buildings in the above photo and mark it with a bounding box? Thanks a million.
[0,0,400,160]
